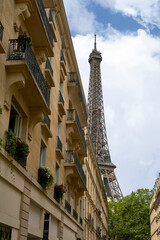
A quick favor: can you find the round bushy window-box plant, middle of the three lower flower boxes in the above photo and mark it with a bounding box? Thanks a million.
[38,167,53,190]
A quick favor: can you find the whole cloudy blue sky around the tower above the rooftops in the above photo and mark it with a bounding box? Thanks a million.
[64,0,160,195]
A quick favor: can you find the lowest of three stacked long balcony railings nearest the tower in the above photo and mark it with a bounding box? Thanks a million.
[65,150,86,186]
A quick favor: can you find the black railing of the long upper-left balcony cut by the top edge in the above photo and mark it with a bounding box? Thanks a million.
[36,0,53,47]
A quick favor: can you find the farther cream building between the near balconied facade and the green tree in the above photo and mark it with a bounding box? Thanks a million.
[84,128,108,240]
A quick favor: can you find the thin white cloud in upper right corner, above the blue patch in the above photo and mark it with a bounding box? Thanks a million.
[94,0,160,28]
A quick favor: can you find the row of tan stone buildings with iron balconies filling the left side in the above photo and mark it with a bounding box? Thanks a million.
[0,0,107,240]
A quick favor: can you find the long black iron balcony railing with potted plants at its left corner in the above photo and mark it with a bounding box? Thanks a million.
[8,39,50,107]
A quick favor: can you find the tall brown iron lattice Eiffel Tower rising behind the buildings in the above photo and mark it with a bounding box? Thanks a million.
[88,35,123,202]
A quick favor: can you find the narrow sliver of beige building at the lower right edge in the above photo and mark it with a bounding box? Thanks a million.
[150,174,160,240]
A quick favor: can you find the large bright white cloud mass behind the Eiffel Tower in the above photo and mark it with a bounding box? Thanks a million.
[73,27,160,195]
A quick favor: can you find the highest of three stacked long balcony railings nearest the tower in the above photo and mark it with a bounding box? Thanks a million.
[68,72,88,119]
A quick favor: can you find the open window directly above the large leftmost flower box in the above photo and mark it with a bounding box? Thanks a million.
[9,105,22,137]
